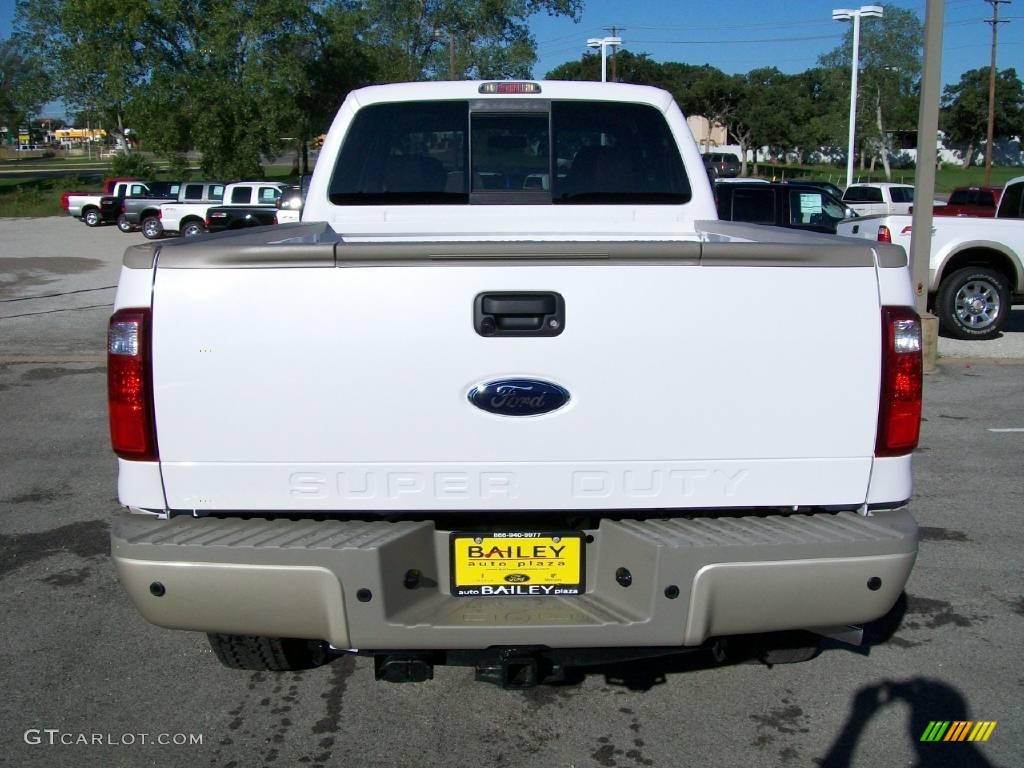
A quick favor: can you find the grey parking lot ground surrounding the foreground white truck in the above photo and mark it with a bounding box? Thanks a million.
[0,219,1024,768]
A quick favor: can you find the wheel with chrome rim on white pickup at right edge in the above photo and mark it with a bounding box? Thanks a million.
[935,266,1010,339]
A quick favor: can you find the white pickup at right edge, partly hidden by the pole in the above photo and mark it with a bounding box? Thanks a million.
[838,176,1024,339]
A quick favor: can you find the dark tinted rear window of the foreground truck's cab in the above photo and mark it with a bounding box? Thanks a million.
[329,99,691,205]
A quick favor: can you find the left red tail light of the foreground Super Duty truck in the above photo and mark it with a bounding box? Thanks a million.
[106,308,159,461]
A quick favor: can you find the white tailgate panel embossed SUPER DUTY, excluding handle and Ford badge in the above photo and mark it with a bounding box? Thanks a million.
[154,265,881,510]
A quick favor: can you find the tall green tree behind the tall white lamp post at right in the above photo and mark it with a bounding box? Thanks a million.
[818,5,924,178]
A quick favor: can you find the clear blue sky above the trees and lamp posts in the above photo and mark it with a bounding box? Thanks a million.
[0,0,1024,120]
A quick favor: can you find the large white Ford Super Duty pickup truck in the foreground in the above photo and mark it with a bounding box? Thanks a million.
[109,82,922,687]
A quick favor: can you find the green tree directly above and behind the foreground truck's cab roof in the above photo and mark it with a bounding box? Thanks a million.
[362,0,583,82]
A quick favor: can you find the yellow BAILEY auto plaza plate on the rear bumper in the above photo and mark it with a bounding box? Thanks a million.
[451,531,584,597]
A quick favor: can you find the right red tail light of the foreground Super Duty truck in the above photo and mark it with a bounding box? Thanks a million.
[874,306,923,456]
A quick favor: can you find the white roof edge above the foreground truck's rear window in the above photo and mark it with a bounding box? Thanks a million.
[348,80,673,112]
